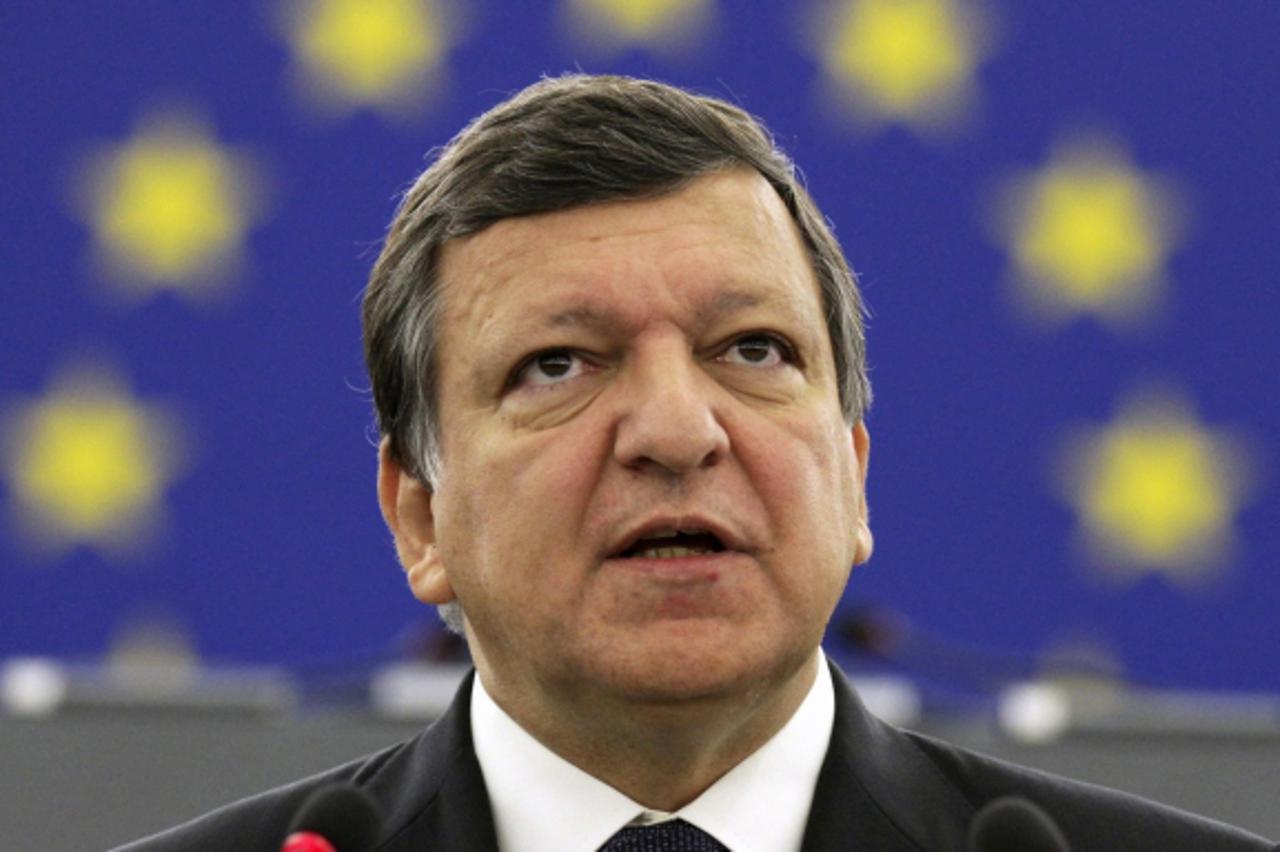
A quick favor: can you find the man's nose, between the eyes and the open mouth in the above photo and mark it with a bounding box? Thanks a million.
[613,340,730,475]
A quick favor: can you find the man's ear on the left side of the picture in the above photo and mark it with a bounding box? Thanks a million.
[378,438,453,604]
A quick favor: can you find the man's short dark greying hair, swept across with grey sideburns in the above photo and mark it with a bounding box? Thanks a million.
[364,74,872,628]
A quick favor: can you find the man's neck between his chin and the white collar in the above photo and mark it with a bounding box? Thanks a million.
[477,654,819,811]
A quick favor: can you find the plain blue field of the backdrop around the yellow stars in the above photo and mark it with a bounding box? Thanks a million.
[0,0,1280,691]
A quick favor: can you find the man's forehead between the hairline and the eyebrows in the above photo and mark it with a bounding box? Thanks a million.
[440,169,822,345]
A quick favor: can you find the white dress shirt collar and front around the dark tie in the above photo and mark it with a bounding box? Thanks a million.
[471,650,836,852]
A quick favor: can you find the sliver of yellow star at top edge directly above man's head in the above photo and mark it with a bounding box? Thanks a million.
[566,0,716,51]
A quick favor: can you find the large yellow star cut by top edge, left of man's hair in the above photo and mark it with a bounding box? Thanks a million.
[283,0,452,113]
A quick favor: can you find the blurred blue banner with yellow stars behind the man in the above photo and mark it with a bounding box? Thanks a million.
[0,0,1280,691]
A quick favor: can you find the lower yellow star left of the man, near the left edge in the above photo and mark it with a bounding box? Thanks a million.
[0,366,180,555]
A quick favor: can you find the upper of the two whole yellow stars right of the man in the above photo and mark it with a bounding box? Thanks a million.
[997,142,1176,321]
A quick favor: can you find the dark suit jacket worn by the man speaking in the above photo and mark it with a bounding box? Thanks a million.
[115,667,1280,852]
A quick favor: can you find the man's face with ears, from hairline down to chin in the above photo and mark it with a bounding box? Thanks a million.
[383,170,870,704]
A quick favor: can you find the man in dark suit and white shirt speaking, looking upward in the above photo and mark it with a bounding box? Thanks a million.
[117,77,1271,852]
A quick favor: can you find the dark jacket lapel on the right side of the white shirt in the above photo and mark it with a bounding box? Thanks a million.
[803,664,973,852]
